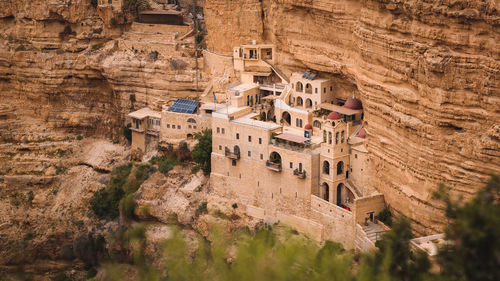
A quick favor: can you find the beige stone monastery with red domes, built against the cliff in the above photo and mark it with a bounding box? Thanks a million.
[129,44,387,250]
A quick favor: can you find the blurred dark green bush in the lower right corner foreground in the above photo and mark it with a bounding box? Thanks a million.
[434,175,500,281]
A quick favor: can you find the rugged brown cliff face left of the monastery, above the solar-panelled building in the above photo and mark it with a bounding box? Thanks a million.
[0,0,206,138]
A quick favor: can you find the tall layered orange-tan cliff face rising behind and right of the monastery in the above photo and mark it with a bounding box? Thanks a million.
[205,0,500,233]
